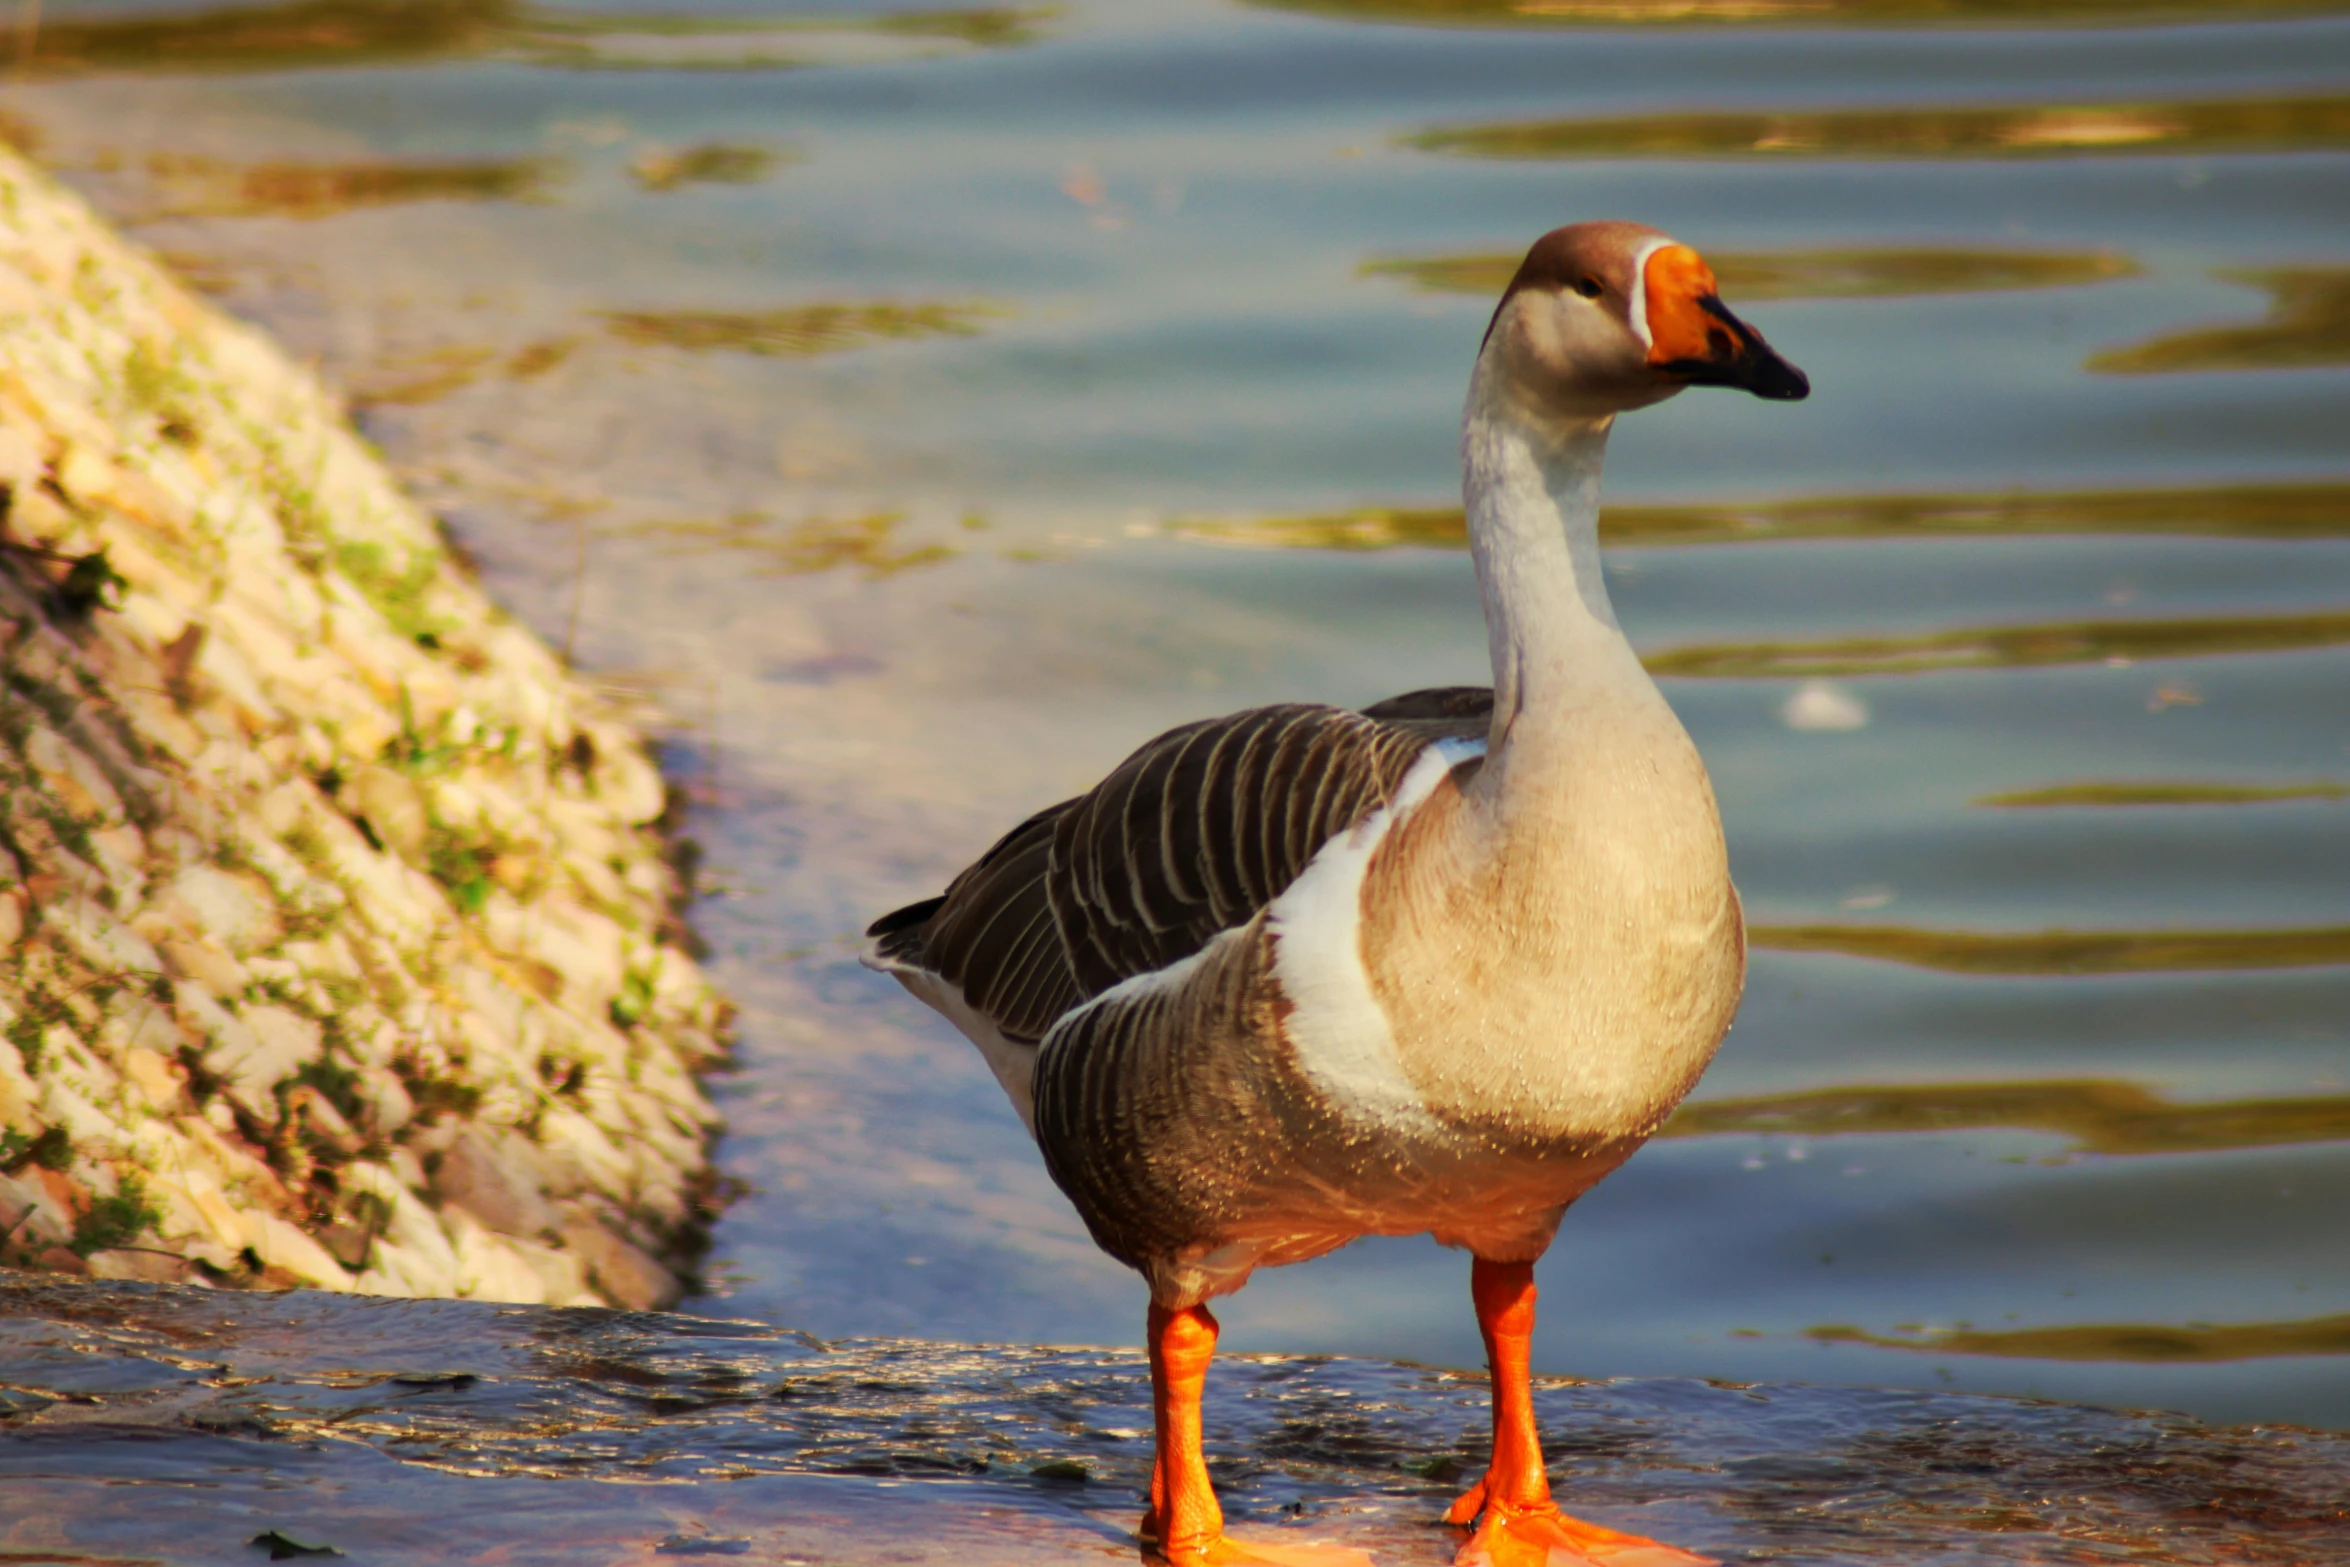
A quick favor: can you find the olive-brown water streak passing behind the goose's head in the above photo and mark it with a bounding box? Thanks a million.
[1356,249,2141,301]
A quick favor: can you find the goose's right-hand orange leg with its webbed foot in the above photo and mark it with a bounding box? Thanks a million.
[1445,1257,1711,1567]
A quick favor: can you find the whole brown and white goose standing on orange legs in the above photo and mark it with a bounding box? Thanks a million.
[865,223,1810,1567]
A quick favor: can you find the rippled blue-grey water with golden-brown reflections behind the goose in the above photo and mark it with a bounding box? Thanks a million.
[7,0,2350,1426]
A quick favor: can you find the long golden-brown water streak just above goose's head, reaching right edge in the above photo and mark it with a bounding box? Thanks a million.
[1403,94,2350,160]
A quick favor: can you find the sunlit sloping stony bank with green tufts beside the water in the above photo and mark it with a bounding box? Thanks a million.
[0,150,724,1306]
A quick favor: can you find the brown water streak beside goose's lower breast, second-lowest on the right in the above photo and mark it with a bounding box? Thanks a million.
[1657,1080,2350,1156]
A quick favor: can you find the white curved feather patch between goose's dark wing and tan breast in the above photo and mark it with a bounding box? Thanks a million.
[1267,740,1485,1135]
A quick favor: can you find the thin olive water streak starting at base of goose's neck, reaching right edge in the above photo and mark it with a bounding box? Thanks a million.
[1643,611,2350,679]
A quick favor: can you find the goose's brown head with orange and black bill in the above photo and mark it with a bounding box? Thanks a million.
[1478,223,1812,423]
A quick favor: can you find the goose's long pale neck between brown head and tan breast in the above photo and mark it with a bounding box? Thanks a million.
[1462,364,1654,754]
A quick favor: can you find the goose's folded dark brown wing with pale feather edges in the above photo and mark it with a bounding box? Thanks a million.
[867,686,1492,1041]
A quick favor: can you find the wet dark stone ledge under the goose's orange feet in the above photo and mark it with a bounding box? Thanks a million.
[0,1276,2350,1567]
